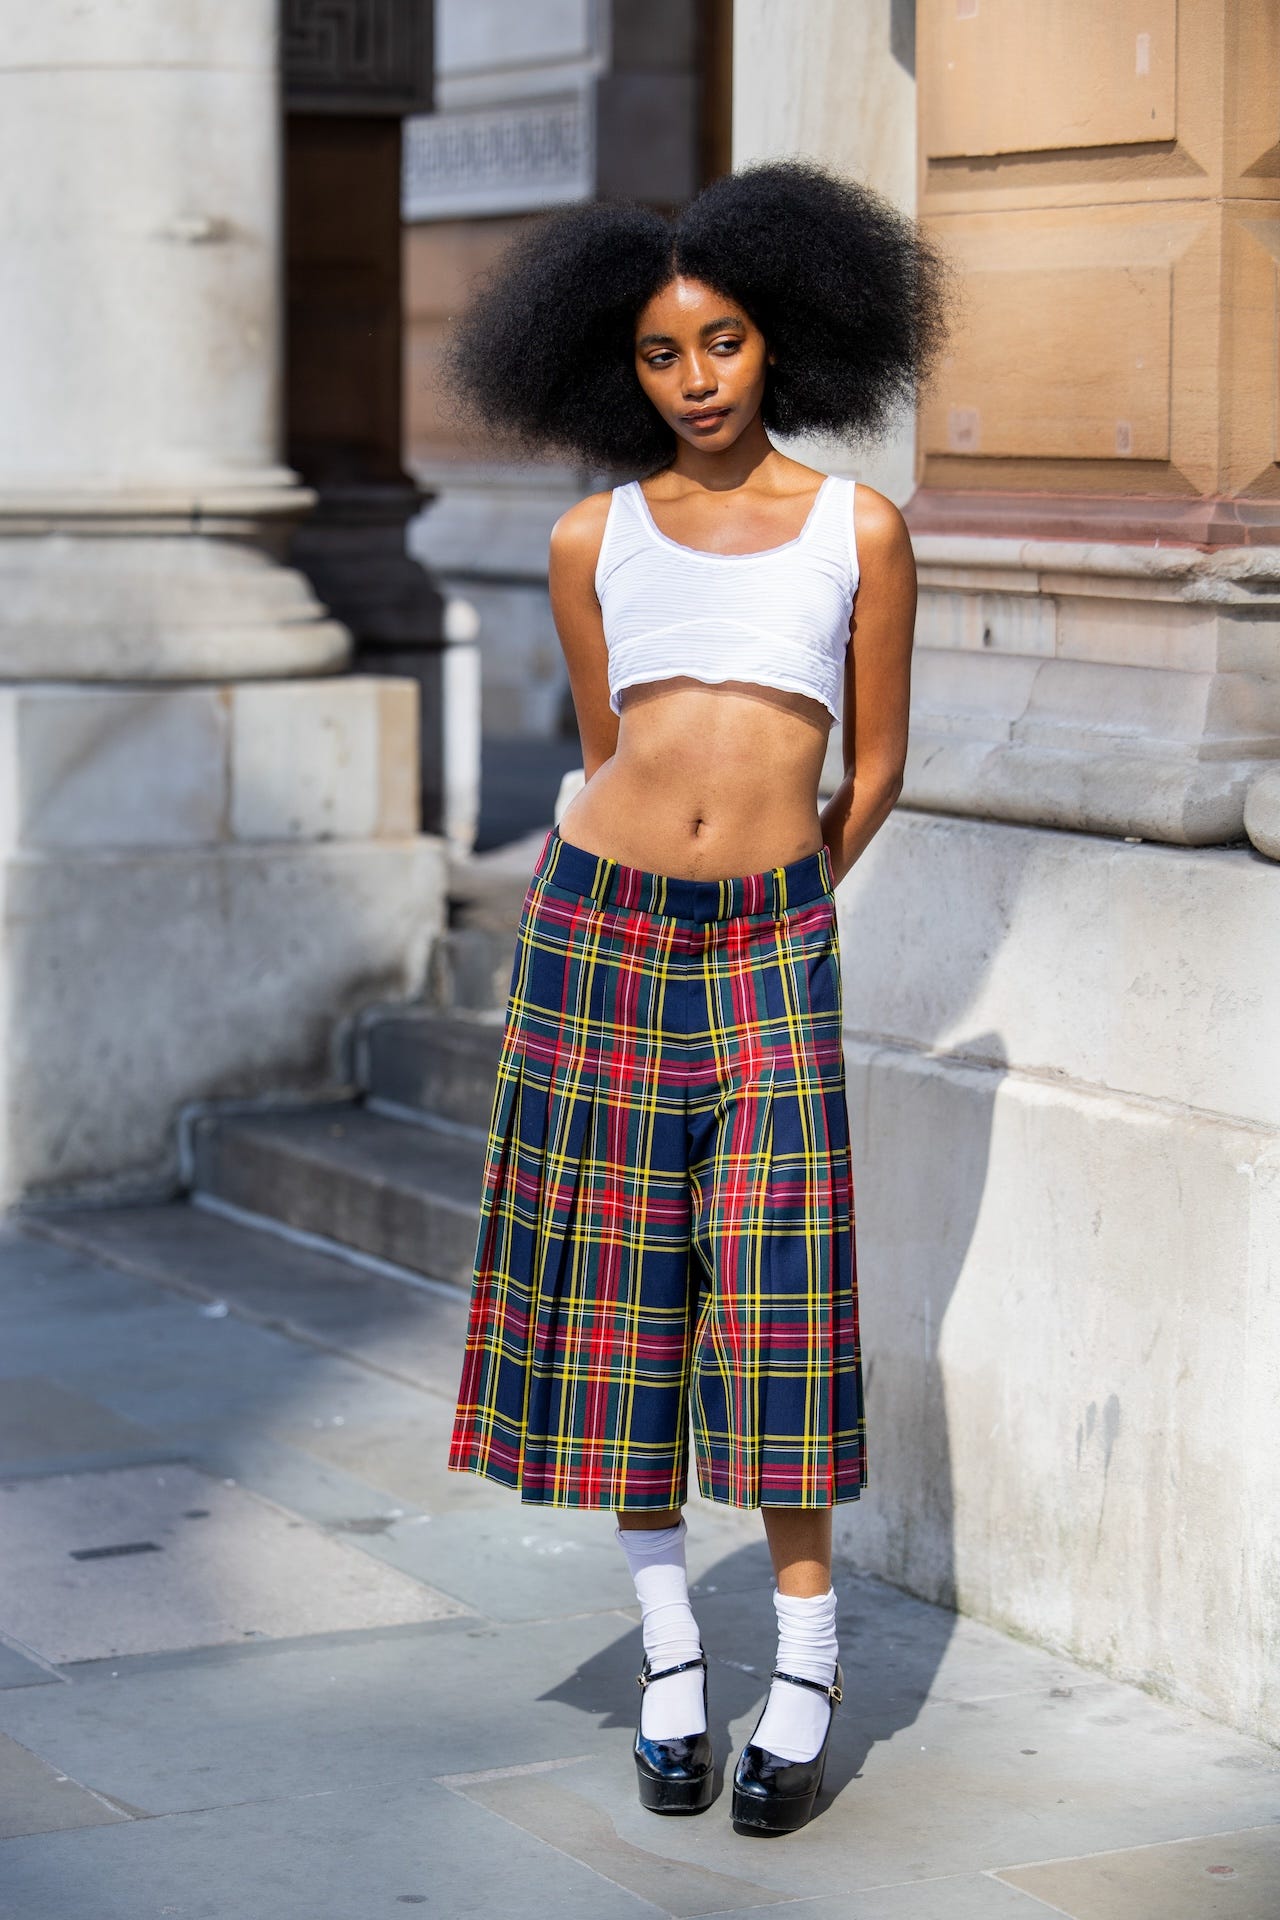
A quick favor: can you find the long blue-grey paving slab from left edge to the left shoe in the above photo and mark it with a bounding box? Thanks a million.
[0,1615,639,1814]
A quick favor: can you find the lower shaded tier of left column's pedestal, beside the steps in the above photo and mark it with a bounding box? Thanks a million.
[0,835,445,1204]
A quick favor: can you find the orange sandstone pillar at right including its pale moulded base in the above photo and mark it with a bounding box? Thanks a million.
[906,0,1280,851]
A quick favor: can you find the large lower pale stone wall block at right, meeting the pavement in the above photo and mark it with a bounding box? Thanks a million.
[837,1041,1280,1740]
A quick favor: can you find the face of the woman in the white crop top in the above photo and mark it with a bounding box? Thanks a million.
[635,276,773,453]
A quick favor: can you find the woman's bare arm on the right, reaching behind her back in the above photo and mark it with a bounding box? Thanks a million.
[821,486,915,885]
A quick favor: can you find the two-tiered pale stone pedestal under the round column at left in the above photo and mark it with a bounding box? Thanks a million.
[0,676,435,1206]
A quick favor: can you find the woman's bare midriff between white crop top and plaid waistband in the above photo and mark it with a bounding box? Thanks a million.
[558,676,831,879]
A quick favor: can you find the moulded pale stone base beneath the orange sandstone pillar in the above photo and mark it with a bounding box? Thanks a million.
[904,536,1280,847]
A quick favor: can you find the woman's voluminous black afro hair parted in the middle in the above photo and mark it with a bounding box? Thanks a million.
[441,159,948,470]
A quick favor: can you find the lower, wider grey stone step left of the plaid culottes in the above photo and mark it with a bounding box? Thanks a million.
[190,1102,486,1286]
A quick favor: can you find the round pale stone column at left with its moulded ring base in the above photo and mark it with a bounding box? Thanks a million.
[0,0,349,680]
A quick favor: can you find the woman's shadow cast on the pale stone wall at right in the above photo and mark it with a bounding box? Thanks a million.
[837,816,1013,1607]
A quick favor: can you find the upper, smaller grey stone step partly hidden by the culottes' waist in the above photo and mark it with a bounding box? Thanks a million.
[355,1008,503,1137]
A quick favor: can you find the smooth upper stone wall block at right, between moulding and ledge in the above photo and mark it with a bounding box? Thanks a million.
[839,806,1280,1127]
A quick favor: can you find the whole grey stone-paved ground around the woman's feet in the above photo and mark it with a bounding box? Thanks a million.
[0,1210,1280,1920]
